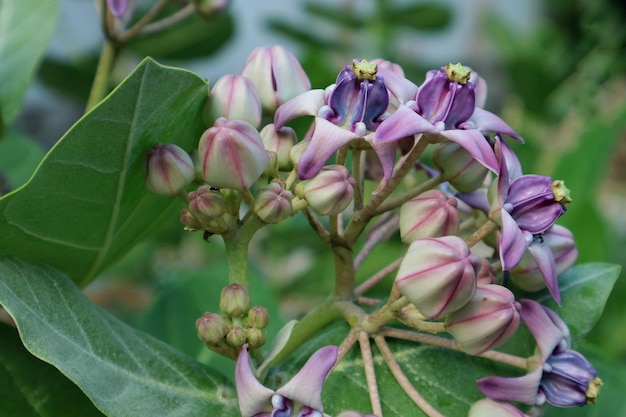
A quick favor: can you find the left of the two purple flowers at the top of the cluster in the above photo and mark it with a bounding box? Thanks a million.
[274,60,417,183]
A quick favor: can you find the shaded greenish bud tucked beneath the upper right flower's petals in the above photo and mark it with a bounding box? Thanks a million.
[433,142,489,193]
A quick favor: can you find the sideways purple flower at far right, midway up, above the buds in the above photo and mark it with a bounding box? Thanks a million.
[489,138,571,303]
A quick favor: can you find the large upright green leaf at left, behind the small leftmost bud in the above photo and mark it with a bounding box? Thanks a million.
[0,58,207,285]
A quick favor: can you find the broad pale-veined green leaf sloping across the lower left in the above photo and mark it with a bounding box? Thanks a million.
[0,257,238,417]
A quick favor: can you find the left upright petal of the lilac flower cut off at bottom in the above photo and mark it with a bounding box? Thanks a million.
[235,346,274,417]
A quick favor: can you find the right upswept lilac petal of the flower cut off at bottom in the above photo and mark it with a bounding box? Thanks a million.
[276,345,339,412]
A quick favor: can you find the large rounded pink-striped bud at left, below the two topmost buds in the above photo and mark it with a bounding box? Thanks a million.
[198,117,269,190]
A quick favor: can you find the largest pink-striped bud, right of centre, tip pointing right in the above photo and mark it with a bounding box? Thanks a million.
[396,236,480,319]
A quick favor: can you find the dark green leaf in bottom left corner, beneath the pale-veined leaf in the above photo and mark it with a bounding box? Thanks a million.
[0,324,103,417]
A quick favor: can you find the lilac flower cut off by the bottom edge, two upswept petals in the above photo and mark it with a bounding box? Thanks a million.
[235,346,338,417]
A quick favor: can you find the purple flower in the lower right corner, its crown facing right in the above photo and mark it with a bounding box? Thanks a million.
[477,300,602,407]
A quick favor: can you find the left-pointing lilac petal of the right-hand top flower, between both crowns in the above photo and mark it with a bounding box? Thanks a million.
[375,106,439,142]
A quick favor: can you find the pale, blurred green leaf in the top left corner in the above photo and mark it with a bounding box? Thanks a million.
[0,0,58,125]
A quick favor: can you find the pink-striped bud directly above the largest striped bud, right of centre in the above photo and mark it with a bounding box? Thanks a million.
[400,190,461,243]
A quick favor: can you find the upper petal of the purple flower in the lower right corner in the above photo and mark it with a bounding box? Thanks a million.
[520,299,569,361]
